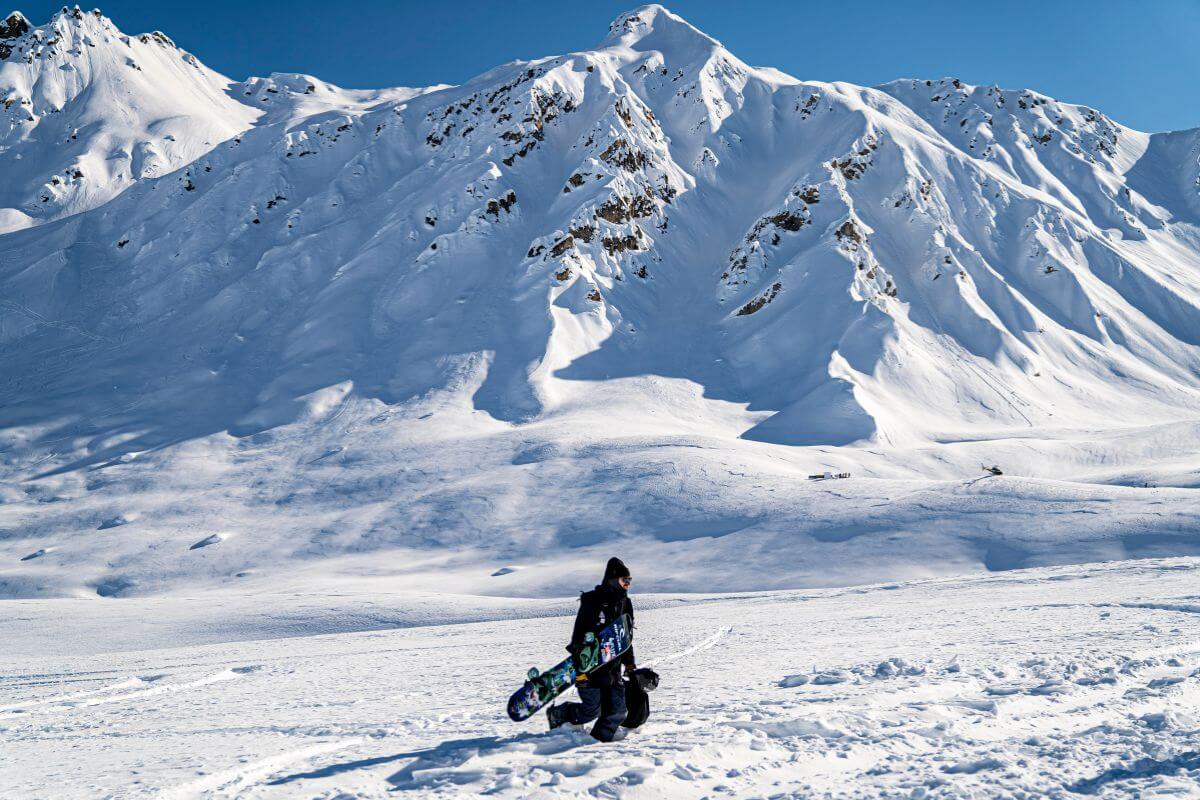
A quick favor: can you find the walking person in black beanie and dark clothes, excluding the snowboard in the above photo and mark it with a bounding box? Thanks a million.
[546,558,636,741]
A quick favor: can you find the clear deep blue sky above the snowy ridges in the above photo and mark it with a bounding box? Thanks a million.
[18,0,1200,131]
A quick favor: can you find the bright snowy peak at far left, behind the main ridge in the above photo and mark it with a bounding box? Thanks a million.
[0,6,258,233]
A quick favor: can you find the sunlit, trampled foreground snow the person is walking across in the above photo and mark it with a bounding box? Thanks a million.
[0,559,1200,800]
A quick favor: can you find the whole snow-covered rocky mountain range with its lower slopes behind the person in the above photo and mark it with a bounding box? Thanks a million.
[0,6,1200,596]
